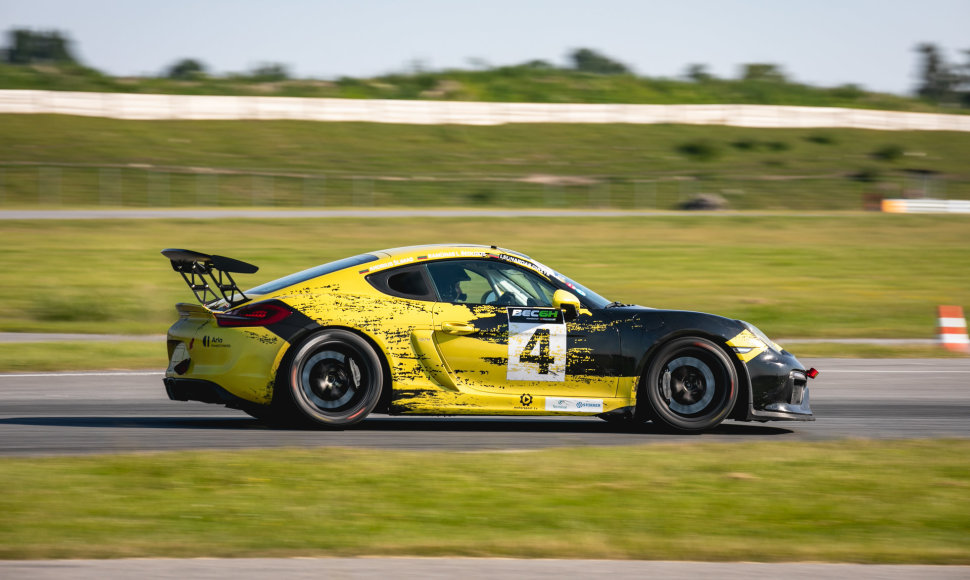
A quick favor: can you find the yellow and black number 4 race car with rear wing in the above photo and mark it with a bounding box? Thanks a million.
[162,245,818,432]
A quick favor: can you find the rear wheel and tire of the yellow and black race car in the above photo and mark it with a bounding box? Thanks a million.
[287,329,384,429]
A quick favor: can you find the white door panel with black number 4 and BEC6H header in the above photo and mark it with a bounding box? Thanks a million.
[507,308,566,381]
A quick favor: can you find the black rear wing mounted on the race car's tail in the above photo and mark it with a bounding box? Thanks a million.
[162,248,259,308]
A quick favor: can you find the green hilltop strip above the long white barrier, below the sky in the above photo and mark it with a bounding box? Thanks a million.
[0,64,952,113]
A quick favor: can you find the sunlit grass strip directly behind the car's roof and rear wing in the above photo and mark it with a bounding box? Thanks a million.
[0,214,970,340]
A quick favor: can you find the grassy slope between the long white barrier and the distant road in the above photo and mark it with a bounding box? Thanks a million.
[0,115,970,210]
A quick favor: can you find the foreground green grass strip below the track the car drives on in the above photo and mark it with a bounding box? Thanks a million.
[0,440,970,564]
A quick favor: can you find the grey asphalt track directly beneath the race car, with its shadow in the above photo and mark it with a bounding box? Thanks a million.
[0,359,970,455]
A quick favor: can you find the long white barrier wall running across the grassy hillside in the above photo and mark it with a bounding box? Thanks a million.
[0,90,970,131]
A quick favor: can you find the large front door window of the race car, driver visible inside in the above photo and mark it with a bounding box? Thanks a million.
[428,260,555,306]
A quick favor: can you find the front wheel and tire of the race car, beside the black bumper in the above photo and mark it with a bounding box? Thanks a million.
[637,336,738,433]
